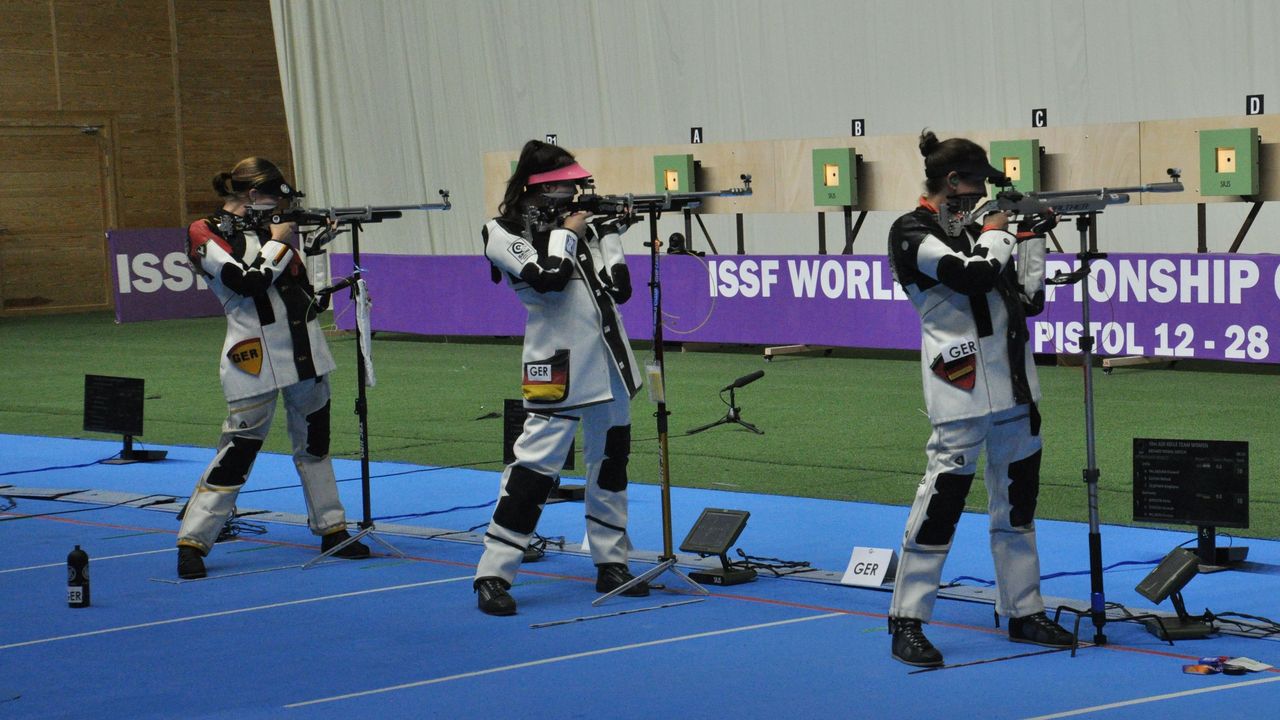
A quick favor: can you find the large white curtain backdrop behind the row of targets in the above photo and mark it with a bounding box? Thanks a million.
[271,0,1280,254]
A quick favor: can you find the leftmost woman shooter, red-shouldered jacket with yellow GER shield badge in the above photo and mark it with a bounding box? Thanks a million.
[178,158,369,579]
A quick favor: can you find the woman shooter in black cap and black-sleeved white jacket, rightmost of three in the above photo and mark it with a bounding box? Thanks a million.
[888,131,1074,666]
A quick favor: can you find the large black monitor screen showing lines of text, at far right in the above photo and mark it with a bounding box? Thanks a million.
[1133,438,1249,528]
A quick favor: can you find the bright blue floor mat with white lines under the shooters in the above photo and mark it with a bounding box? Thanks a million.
[0,436,1280,719]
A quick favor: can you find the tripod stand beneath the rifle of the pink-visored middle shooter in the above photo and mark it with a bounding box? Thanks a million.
[591,208,710,606]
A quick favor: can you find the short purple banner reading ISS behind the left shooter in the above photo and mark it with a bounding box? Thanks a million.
[106,228,223,323]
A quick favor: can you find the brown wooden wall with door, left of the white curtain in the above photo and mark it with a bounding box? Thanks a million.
[0,0,293,314]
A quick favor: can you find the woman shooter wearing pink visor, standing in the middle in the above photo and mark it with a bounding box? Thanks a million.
[474,140,649,615]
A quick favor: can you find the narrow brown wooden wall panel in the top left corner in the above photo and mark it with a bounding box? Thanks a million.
[0,0,58,111]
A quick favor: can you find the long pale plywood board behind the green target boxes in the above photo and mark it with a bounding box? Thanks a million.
[484,115,1218,213]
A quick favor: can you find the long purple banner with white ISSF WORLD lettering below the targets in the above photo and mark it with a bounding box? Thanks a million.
[332,254,1280,363]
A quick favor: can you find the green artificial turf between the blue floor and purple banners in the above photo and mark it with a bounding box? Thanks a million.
[0,313,1280,537]
